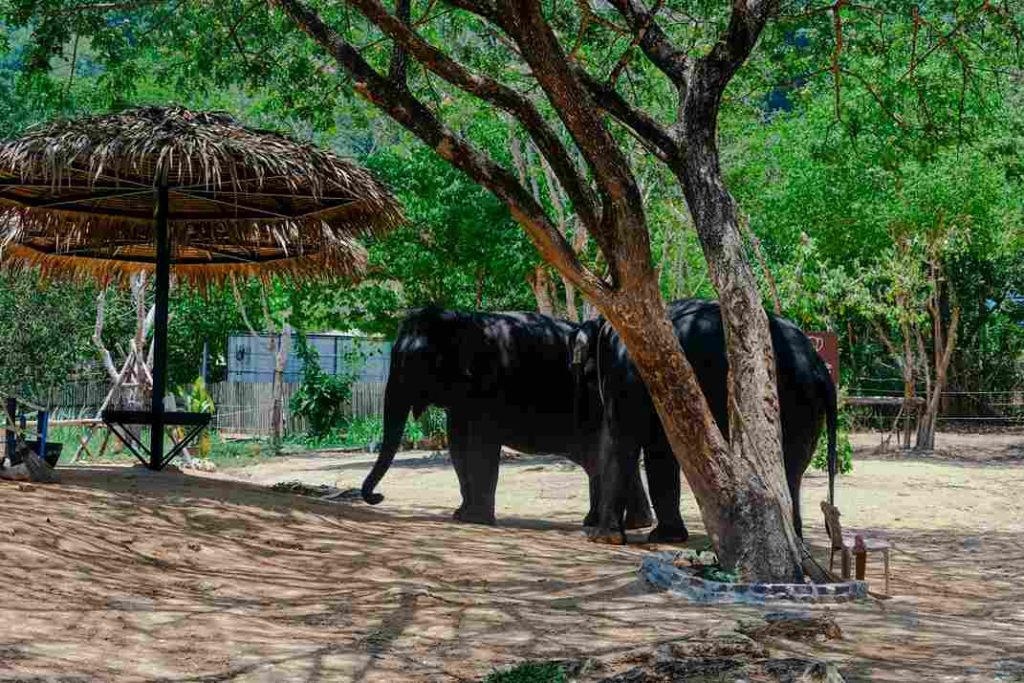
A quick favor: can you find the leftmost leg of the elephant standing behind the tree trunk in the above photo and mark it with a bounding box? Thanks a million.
[588,427,640,545]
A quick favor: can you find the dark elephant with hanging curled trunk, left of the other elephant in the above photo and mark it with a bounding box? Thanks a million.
[361,307,653,528]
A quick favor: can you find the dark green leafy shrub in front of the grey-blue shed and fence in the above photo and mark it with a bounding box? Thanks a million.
[291,334,355,439]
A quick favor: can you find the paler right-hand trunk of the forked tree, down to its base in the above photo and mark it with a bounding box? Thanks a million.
[643,121,803,581]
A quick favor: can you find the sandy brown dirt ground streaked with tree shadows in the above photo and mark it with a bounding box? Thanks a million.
[0,434,1024,682]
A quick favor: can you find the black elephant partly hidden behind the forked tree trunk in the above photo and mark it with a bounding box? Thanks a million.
[573,299,836,543]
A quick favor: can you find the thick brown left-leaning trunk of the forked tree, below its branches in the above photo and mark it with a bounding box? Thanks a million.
[606,278,803,582]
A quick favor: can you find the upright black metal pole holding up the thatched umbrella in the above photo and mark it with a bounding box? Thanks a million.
[150,182,171,470]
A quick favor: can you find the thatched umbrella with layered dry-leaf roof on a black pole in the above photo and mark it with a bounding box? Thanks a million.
[0,108,401,468]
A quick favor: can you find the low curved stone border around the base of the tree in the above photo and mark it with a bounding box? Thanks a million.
[637,552,867,604]
